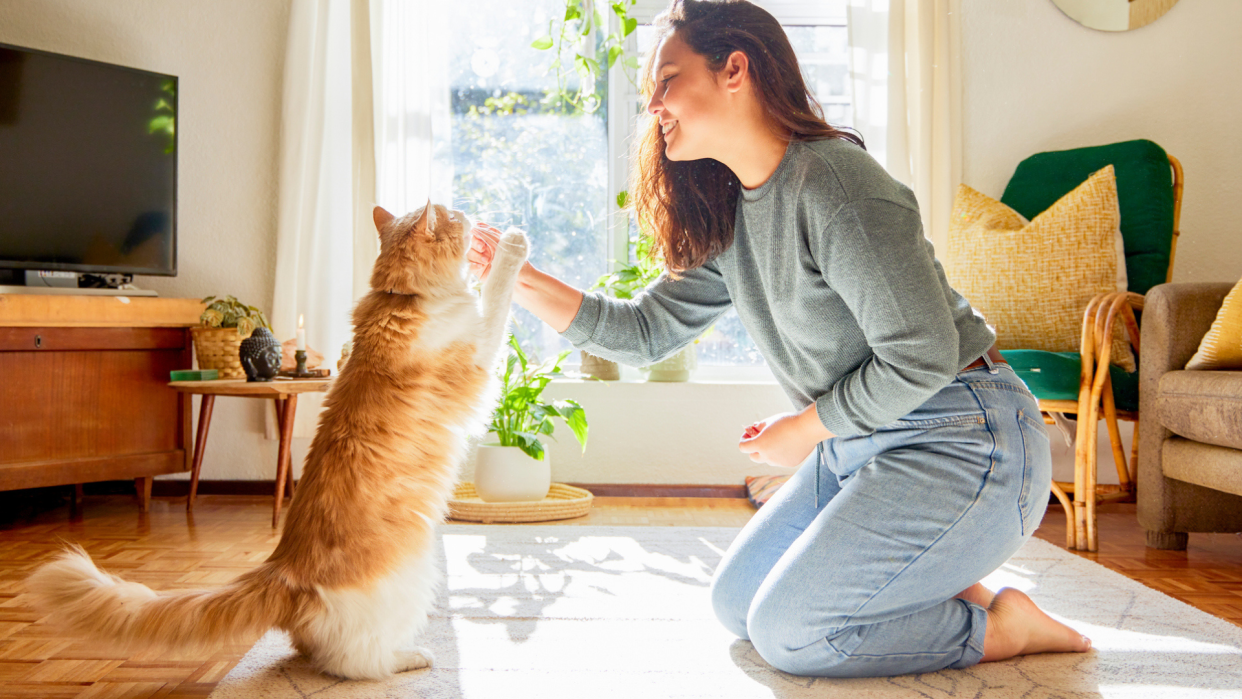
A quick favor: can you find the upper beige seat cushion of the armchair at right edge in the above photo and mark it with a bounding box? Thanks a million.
[1155,371,1242,449]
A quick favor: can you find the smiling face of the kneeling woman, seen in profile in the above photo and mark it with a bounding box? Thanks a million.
[647,32,729,160]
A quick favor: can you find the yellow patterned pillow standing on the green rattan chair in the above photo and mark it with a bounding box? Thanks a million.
[944,165,1135,371]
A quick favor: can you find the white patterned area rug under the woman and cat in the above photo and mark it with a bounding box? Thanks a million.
[211,525,1242,699]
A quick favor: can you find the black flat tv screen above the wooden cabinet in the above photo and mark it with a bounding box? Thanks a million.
[0,43,178,276]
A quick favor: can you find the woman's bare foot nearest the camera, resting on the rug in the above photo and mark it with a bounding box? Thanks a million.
[980,587,1090,663]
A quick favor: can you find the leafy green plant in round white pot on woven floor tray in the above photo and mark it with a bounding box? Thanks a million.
[474,335,586,503]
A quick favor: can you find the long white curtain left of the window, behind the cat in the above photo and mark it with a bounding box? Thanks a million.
[267,0,451,438]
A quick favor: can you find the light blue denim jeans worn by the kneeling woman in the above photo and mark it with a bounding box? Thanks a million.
[712,364,1052,677]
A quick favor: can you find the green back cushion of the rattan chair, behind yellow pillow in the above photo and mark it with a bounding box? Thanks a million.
[1001,140,1174,294]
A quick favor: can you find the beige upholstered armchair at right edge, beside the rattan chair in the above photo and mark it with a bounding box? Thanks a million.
[1138,283,1242,550]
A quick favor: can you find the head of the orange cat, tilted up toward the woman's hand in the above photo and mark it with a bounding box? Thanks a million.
[371,202,472,294]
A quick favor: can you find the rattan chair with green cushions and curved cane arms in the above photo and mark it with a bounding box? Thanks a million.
[1001,140,1182,551]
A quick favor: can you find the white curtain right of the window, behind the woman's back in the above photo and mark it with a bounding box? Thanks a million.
[847,0,961,250]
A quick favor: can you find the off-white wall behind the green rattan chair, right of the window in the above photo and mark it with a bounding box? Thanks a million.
[961,0,1242,483]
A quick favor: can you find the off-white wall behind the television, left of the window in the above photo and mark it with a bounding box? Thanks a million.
[0,0,289,479]
